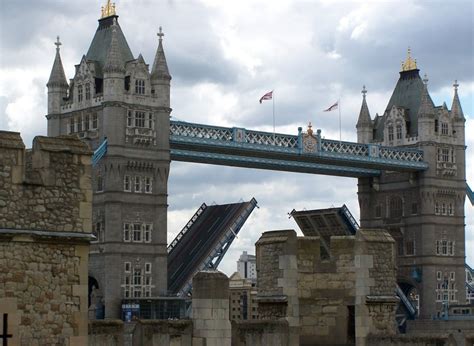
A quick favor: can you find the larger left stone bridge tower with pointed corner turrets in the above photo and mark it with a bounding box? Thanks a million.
[46,1,171,317]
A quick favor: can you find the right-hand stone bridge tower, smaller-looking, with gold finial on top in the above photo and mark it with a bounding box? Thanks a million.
[357,51,466,318]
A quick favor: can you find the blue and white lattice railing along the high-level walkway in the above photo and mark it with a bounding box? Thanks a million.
[170,121,428,170]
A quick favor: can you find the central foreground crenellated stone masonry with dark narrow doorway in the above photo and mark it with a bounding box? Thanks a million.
[256,229,398,345]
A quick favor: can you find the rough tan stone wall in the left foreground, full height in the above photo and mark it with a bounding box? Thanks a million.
[0,131,92,345]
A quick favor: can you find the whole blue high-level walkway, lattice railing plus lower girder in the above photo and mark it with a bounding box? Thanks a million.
[170,121,428,177]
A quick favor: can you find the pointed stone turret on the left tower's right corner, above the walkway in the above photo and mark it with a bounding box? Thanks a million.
[151,26,171,107]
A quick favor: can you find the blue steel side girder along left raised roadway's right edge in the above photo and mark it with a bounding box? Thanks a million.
[178,198,257,297]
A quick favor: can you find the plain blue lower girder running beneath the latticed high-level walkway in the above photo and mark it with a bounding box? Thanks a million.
[170,149,380,177]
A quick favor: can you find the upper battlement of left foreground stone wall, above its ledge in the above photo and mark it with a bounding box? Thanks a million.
[0,131,92,233]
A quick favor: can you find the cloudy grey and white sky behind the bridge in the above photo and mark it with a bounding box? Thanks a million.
[0,0,474,274]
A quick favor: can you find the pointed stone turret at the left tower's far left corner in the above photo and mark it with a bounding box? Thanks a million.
[46,36,69,125]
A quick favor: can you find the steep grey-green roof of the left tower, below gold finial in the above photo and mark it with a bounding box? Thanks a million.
[86,16,134,72]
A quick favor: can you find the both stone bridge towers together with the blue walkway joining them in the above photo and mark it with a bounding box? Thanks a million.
[46,2,473,318]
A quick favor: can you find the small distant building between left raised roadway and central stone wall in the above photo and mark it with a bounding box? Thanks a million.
[229,272,258,321]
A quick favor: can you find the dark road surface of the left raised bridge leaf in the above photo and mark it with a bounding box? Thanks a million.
[168,202,254,294]
